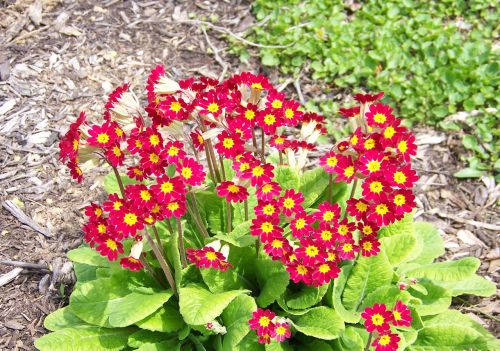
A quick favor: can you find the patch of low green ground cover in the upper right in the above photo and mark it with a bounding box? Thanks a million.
[234,0,500,177]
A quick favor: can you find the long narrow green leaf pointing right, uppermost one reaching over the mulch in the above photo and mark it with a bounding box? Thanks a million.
[403,257,480,282]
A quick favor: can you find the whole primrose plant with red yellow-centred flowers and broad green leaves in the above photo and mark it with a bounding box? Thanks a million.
[36,66,498,351]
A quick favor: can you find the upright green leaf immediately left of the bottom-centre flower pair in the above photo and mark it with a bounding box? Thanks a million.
[221,295,257,351]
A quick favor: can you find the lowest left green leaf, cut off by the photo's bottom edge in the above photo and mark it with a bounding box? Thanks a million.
[35,327,136,351]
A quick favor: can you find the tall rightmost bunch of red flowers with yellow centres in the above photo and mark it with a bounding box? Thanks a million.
[320,92,418,256]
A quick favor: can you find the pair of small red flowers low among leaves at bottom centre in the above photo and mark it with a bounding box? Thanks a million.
[248,308,291,344]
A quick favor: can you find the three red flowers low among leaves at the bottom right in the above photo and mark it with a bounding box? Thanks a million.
[361,301,412,351]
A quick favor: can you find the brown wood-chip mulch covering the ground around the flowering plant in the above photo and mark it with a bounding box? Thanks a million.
[0,0,500,350]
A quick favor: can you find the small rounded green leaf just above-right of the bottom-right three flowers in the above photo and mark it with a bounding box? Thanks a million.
[411,282,451,316]
